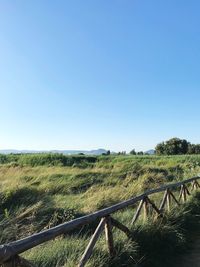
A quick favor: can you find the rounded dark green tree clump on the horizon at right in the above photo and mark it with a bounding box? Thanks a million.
[155,138,200,155]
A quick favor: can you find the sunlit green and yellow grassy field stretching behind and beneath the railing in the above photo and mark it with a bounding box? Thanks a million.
[0,154,200,267]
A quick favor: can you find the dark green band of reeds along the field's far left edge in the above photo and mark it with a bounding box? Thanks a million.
[0,153,97,167]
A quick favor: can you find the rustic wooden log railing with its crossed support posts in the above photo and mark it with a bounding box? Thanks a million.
[0,177,200,267]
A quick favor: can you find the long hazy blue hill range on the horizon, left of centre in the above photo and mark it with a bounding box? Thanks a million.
[0,148,107,155]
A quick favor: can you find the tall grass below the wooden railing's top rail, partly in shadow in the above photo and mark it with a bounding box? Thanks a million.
[21,193,200,267]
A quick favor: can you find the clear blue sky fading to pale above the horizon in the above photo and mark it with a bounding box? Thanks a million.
[0,0,200,151]
